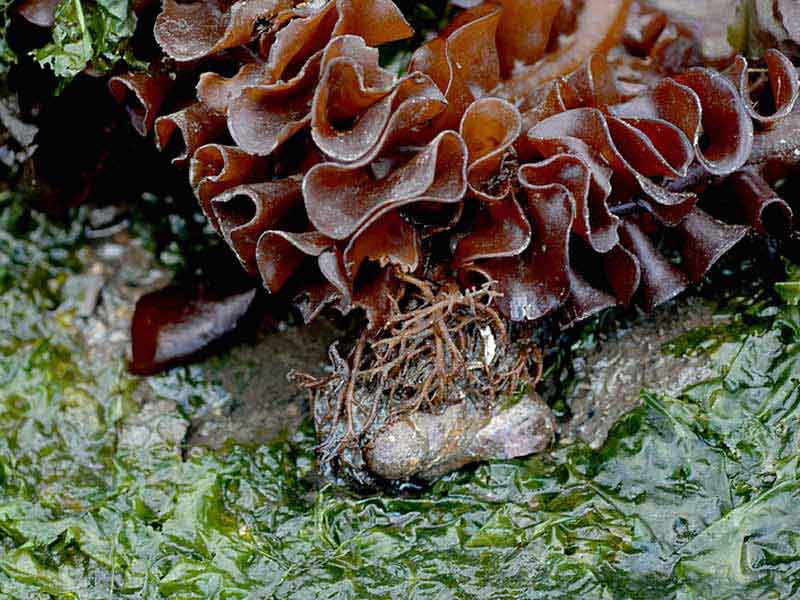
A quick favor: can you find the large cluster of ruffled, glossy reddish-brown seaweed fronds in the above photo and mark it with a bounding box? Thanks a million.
[109,0,800,350]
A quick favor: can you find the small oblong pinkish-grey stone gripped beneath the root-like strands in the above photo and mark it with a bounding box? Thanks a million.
[365,392,555,480]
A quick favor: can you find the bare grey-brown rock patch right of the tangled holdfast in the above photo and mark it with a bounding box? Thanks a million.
[561,298,716,448]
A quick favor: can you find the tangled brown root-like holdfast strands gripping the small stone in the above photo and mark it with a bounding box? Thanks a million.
[294,273,542,483]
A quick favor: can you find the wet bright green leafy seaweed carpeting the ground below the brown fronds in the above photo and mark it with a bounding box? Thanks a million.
[0,196,800,600]
